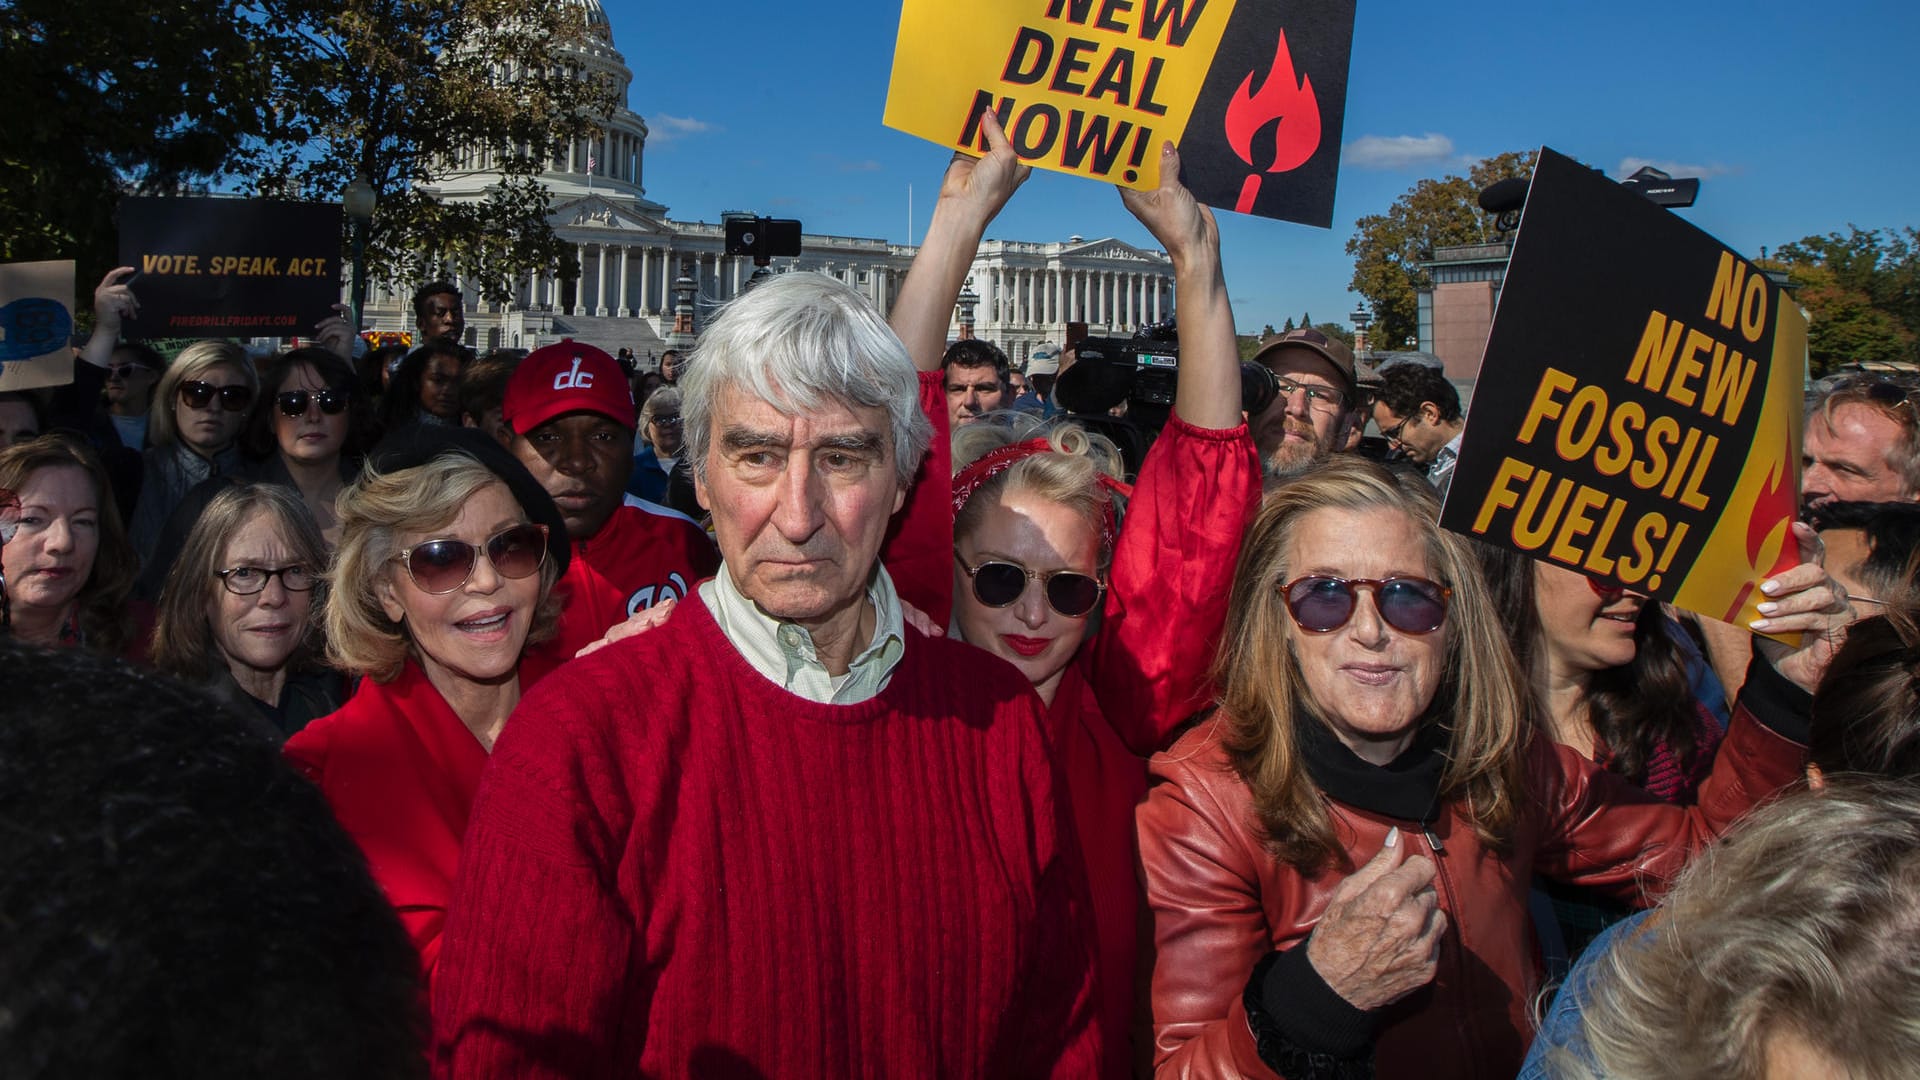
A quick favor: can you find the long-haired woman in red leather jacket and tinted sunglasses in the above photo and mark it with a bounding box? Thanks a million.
[1139,459,1849,1080]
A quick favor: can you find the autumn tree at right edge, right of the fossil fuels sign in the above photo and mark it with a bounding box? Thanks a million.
[1761,225,1920,377]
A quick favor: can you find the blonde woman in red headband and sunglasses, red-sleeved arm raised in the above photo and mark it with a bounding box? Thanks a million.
[952,146,1260,1076]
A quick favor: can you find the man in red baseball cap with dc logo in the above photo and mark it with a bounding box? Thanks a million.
[501,340,720,615]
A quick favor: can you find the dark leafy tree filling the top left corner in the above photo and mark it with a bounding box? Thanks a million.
[0,0,276,269]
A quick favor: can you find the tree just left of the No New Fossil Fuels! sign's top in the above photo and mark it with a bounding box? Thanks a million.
[1346,150,1536,348]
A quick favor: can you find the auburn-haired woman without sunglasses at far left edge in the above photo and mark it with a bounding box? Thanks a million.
[0,434,134,653]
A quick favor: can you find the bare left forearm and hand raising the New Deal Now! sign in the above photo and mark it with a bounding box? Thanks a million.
[887,111,1033,371]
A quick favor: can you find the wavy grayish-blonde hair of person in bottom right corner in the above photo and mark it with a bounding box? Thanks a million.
[1553,778,1920,1080]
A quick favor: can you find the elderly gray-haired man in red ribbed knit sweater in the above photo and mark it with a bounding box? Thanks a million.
[434,265,1102,1076]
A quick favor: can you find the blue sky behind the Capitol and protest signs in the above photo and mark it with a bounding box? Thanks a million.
[603,0,1920,332]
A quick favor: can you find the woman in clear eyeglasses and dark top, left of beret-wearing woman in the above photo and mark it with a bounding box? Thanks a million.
[152,484,346,738]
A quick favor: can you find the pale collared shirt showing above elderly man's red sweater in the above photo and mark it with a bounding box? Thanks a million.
[699,563,906,705]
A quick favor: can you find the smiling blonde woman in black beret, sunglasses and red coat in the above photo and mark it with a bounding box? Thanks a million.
[286,427,605,978]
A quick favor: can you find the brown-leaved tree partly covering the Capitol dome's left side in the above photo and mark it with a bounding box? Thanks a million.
[252,0,616,300]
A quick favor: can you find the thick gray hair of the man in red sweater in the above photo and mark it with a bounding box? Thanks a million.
[680,273,933,486]
